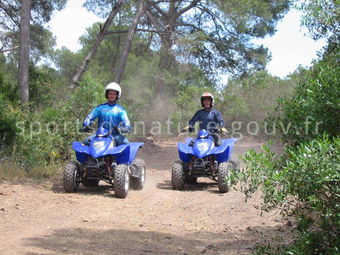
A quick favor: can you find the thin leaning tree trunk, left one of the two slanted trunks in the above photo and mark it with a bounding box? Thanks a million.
[69,0,125,89]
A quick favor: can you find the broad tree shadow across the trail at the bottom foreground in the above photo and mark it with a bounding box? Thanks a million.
[25,226,286,255]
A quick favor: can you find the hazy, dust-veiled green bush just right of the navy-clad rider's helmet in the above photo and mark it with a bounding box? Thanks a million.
[216,71,297,135]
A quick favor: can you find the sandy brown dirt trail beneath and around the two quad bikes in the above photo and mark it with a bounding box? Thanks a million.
[0,139,291,255]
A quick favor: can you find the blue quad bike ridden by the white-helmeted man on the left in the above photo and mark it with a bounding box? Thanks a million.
[63,127,146,198]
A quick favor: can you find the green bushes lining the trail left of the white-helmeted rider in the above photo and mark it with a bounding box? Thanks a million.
[0,76,105,178]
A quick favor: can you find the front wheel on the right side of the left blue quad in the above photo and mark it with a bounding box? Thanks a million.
[113,164,130,198]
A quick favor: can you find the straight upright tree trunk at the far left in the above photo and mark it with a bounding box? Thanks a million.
[18,0,32,104]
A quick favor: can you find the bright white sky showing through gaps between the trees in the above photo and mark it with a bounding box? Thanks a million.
[49,0,326,78]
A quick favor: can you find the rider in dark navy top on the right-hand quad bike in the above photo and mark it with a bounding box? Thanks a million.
[183,92,228,146]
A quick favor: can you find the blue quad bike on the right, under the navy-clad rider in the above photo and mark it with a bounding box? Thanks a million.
[171,129,239,193]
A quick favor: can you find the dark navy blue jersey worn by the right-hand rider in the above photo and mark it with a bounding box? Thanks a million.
[189,109,225,132]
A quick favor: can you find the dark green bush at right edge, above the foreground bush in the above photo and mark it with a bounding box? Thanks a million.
[267,61,340,144]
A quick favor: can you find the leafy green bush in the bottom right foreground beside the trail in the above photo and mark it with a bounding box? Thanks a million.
[239,136,340,254]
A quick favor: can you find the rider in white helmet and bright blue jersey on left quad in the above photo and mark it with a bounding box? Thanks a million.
[81,82,131,145]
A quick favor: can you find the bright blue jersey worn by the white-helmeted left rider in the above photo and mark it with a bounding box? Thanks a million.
[83,102,131,133]
